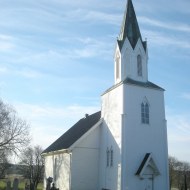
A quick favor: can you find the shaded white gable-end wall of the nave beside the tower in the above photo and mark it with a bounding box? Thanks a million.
[71,124,100,190]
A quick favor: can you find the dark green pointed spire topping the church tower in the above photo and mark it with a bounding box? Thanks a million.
[118,0,145,48]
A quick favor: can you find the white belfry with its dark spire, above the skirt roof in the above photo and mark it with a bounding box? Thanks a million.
[115,0,148,84]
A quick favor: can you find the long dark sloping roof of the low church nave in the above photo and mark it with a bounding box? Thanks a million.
[43,111,101,153]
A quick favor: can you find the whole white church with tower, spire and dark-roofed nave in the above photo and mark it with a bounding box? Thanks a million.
[42,0,169,190]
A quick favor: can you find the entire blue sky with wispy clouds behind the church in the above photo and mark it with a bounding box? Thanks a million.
[0,0,190,162]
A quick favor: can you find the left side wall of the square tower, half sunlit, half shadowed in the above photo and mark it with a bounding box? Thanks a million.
[99,85,123,190]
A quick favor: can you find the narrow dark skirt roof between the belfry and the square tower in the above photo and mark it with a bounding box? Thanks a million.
[102,78,164,95]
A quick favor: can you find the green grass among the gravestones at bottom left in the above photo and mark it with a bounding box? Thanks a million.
[0,179,43,190]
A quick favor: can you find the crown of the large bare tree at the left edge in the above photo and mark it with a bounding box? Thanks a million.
[0,100,30,153]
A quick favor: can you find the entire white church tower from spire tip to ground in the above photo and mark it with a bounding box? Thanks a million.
[100,0,169,190]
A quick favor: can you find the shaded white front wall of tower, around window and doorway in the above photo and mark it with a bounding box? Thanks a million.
[122,85,168,190]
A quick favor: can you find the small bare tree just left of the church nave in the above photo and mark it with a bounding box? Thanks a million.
[20,146,44,190]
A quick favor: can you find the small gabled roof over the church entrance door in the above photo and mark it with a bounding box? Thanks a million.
[135,153,160,178]
